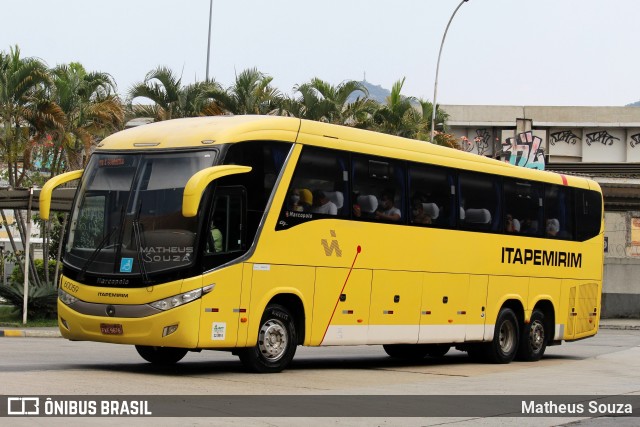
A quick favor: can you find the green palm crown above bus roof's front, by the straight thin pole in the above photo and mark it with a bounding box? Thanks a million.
[129,66,223,121]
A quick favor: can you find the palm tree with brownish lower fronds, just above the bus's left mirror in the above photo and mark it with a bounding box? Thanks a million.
[52,62,124,172]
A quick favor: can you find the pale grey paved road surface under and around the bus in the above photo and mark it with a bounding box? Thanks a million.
[0,330,640,427]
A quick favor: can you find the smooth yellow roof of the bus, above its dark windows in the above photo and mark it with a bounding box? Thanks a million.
[98,115,600,191]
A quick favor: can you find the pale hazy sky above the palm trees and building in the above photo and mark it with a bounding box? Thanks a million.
[0,0,640,106]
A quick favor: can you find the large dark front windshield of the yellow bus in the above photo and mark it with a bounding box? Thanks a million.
[64,151,216,282]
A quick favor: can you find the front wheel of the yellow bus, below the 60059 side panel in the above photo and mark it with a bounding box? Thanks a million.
[237,304,297,373]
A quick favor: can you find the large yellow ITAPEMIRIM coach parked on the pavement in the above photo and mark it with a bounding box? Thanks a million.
[40,116,603,372]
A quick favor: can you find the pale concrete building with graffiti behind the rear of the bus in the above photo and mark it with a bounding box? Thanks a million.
[441,105,640,318]
